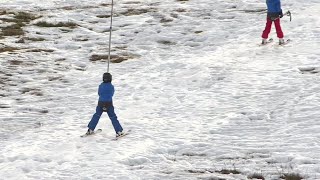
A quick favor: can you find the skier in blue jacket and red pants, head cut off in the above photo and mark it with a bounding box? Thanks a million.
[262,0,284,45]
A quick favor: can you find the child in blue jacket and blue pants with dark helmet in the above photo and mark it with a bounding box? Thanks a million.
[86,73,123,137]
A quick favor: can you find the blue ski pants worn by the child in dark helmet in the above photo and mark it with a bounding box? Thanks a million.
[88,106,123,133]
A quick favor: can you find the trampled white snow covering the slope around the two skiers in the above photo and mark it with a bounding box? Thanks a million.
[0,0,320,179]
